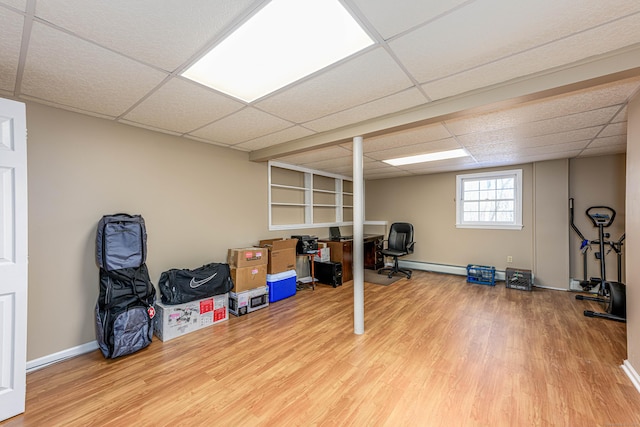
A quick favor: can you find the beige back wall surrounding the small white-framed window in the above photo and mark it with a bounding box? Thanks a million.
[365,164,533,270]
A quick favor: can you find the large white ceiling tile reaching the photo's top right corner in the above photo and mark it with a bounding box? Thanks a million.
[389,0,640,83]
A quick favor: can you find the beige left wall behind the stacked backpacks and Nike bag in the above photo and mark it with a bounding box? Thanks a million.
[27,103,286,360]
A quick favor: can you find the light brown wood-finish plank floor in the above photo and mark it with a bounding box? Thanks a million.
[0,271,640,427]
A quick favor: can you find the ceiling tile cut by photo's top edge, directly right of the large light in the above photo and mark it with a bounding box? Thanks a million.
[354,0,467,40]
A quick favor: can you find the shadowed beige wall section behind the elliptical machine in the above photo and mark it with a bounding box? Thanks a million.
[567,154,626,282]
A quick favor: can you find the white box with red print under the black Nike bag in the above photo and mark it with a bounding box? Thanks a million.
[154,293,229,341]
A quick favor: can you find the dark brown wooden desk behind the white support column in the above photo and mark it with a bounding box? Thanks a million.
[319,234,384,283]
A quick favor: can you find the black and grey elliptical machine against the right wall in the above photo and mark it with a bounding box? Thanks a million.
[569,198,627,322]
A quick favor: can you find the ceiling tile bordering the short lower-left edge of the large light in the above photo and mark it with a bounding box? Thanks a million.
[124,79,244,133]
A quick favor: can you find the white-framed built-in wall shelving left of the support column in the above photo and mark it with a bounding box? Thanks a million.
[269,162,353,230]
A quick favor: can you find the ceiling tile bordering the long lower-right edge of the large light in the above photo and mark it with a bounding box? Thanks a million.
[256,48,413,123]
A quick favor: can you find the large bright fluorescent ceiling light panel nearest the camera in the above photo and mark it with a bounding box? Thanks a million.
[182,0,373,102]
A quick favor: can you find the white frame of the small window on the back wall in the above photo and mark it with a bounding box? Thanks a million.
[456,169,523,230]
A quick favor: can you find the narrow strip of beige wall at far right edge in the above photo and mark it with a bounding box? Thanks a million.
[625,95,640,372]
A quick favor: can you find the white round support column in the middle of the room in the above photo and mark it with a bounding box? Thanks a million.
[353,136,364,335]
